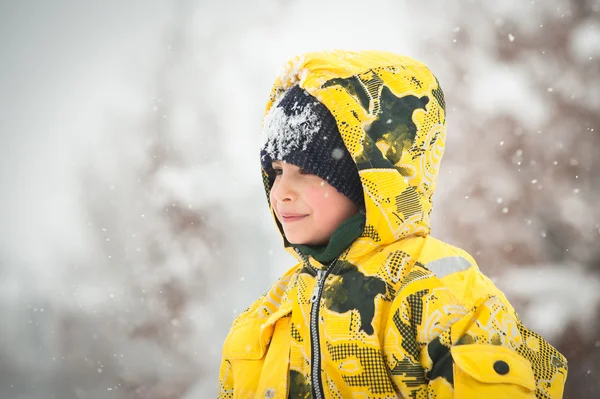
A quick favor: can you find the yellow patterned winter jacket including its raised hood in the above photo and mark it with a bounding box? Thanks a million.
[219,51,567,399]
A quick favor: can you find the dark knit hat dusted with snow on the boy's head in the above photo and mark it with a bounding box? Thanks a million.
[260,85,364,208]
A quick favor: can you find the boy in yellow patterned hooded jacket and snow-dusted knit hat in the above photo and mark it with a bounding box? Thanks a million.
[219,51,567,399]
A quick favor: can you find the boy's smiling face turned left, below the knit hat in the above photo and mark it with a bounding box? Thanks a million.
[270,161,358,245]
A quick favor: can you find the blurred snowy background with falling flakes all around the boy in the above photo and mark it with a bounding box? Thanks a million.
[0,0,600,399]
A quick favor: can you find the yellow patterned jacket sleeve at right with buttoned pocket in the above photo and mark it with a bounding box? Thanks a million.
[384,265,567,399]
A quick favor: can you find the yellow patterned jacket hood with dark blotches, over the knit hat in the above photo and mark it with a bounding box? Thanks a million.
[262,51,446,255]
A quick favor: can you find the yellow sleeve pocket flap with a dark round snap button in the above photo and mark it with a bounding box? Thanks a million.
[450,344,535,399]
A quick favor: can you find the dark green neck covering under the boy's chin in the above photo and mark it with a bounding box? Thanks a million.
[286,211,366,264]
